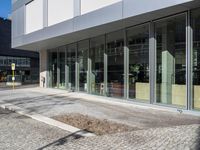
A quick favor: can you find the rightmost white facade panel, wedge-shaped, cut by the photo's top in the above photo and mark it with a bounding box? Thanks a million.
[81,0,122,15]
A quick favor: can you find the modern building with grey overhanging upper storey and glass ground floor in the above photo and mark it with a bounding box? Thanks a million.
[13,0,200,110]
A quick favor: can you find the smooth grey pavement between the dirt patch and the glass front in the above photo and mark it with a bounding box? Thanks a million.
[1,90,200,129]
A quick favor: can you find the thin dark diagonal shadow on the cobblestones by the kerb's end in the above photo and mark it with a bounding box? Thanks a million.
[37,130,86,150]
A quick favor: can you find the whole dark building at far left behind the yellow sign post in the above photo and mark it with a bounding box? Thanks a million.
[0,18,39,84]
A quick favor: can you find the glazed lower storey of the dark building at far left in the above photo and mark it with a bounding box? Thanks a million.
[0,56,39,84]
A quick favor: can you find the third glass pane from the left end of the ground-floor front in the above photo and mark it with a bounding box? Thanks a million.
[66,44,77,90]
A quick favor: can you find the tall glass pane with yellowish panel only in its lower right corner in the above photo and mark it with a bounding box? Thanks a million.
[127,24,150,100]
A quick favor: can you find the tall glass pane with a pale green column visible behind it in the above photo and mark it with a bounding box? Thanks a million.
[155,14,186,107]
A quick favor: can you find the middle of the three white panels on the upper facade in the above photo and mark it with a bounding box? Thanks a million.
[48,0,74,26]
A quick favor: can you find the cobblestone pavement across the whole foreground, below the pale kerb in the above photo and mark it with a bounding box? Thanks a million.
[0,108,200,150]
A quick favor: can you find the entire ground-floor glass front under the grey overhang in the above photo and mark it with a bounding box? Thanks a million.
[48,9,200,110]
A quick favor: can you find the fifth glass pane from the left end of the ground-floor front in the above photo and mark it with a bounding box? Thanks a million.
[90,36,105,95]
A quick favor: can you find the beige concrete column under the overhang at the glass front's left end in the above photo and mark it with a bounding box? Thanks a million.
[39,50,48,88]
